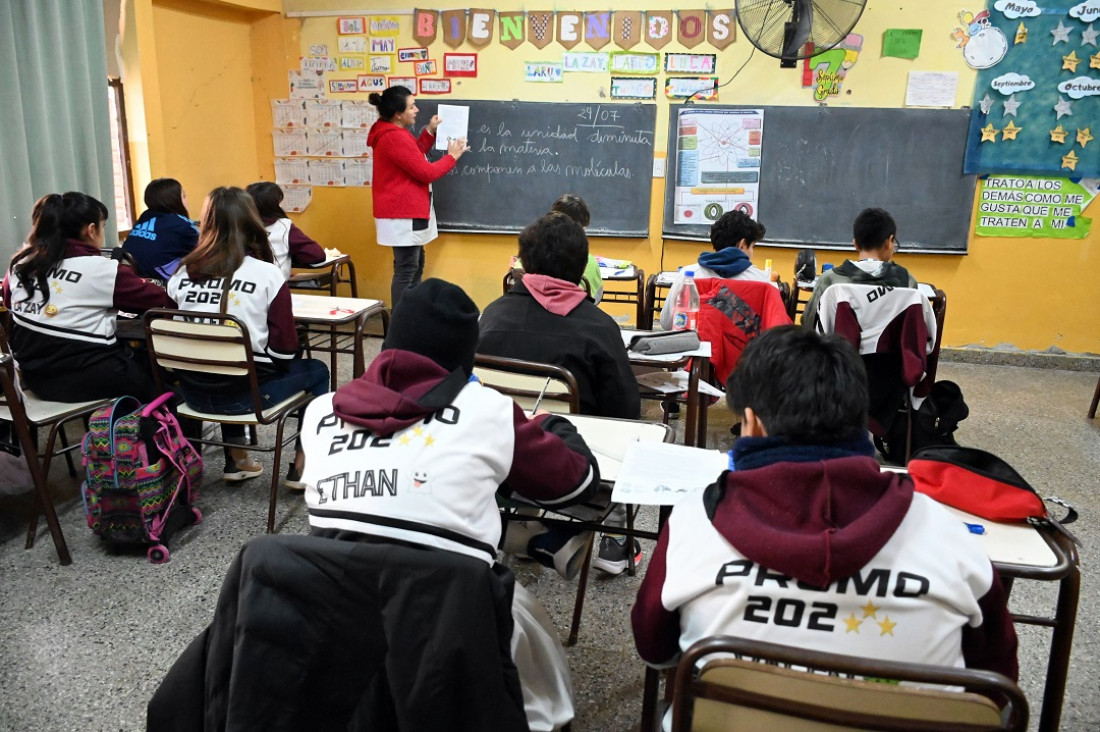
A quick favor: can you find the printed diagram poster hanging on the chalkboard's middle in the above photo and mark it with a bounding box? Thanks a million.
[673,109,763,225]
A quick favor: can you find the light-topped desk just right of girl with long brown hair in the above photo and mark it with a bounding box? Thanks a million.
[290,293,389,390]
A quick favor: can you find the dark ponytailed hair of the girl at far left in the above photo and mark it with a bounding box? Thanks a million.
[11,192,107,303]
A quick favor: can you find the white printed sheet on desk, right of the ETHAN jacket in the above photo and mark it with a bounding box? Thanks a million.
[612,435,729,505]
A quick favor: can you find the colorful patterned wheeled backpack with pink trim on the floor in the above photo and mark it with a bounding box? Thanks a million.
[80,392,202,564]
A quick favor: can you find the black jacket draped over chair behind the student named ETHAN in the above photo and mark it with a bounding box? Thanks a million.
[147,535,527,732]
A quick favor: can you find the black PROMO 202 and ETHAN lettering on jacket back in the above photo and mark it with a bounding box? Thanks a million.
[315,405,462,504]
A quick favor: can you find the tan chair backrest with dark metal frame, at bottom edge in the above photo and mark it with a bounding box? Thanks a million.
[672,636,1027,732]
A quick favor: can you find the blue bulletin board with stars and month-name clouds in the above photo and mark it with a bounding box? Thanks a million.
[968,0,1100,178]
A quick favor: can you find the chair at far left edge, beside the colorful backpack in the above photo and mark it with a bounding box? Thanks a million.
[0,326,111,550]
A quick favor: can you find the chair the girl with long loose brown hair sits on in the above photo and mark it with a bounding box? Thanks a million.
[145,308,314,534]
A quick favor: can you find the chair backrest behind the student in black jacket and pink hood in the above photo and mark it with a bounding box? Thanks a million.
[474,353,581,414]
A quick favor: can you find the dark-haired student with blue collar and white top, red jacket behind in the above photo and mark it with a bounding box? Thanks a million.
[661,206,771,330]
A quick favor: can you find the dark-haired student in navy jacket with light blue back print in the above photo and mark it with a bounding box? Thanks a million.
[122,178,199,280]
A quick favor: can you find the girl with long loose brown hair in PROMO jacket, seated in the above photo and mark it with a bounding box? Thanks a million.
[162,187,329,488]
